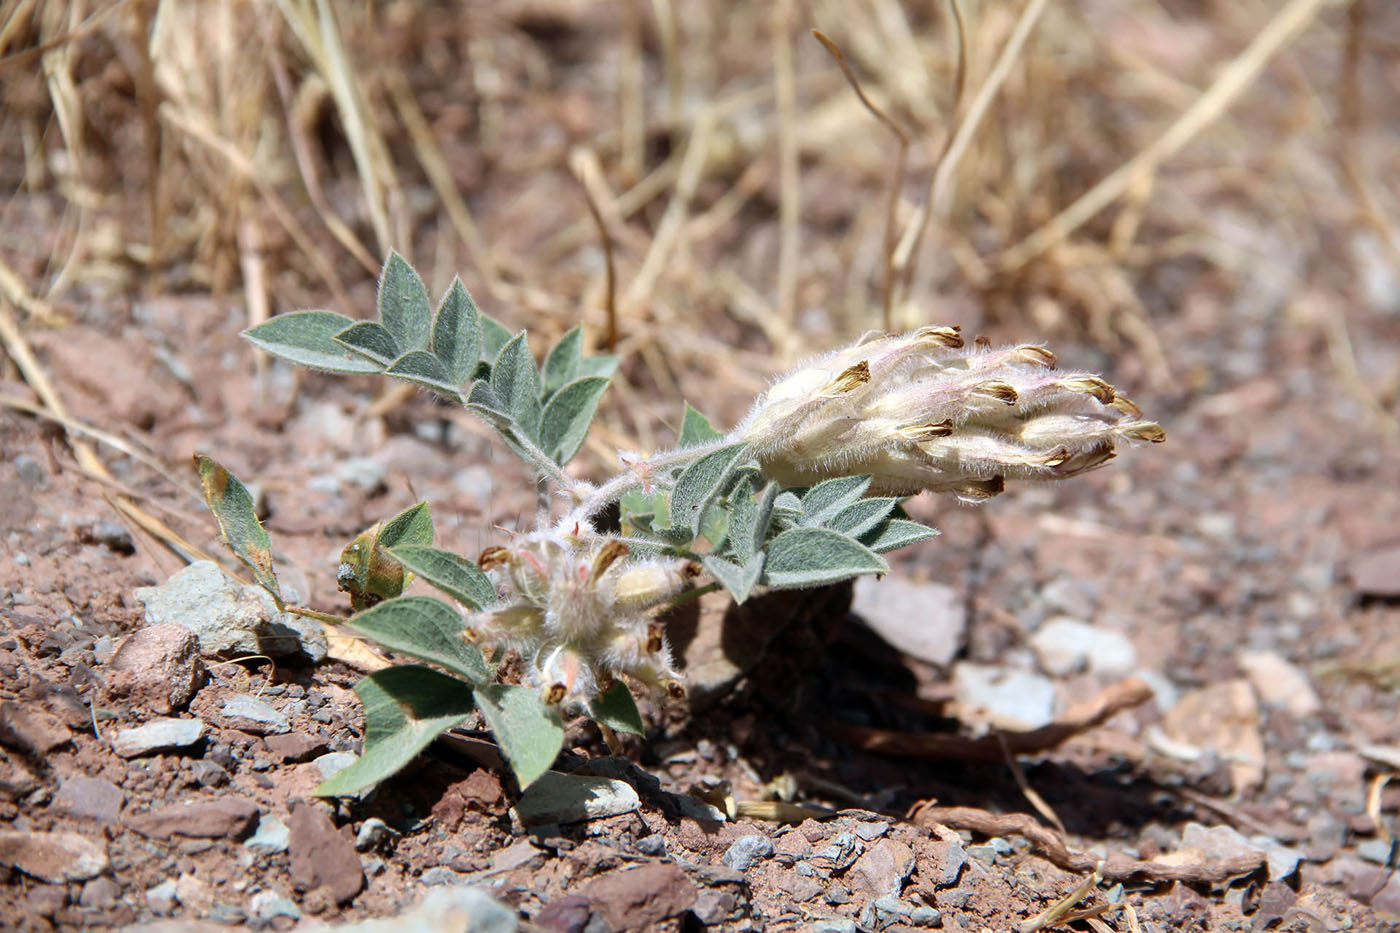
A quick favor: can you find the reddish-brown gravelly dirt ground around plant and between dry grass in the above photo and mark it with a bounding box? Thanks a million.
[0,4,1400,932]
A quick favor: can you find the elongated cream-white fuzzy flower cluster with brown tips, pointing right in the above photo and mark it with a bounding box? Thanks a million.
[735,326,1166,500]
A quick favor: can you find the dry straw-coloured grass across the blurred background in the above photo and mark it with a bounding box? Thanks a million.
[0,0,1400,447]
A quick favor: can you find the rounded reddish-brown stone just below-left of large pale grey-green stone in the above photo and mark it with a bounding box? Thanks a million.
[106,622,204,713]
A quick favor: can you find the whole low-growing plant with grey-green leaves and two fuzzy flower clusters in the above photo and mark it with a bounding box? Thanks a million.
[196,252,1163,796]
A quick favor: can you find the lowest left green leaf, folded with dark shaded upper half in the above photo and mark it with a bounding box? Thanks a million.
[315,664,473,797]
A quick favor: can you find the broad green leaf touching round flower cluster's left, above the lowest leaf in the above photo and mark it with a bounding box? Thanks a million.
[346,597,490,684]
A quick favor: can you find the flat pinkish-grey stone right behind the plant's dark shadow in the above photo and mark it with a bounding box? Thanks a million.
[851,577,967,667]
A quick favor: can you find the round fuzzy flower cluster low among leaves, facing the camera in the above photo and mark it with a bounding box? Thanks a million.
[468,531,697,705]
